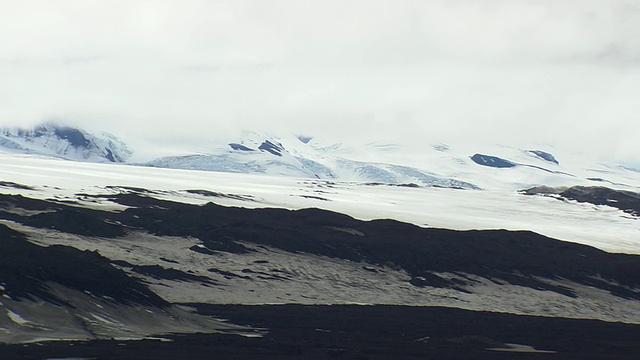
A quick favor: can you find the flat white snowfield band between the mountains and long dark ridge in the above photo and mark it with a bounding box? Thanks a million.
[0,154,640,254]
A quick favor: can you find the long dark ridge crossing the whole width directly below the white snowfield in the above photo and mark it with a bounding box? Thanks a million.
[0,193,640,300]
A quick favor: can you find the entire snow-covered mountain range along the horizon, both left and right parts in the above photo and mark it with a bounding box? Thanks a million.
[0,123,640,191]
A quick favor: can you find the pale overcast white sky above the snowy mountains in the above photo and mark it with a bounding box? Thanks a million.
[0,0,640,163]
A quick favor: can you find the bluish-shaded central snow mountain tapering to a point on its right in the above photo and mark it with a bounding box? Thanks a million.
[146,132,478,189]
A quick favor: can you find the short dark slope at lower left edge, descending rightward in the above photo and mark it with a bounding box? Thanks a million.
[0,225,168,307]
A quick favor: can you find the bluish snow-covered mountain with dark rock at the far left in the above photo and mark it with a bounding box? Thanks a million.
[0,123,132,163]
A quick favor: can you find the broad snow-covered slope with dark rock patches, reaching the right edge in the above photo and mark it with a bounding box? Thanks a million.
[141,132,640,191]
